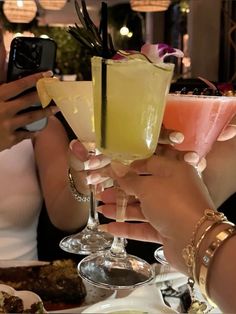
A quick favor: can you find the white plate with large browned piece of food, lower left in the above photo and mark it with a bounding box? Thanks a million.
[0,259,114,313]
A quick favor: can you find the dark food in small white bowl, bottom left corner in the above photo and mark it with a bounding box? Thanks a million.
[0,291,45,314]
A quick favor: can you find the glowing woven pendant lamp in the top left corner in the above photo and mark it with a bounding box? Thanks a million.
[3,0,37,23]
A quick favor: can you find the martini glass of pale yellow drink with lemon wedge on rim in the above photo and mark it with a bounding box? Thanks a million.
[37,78,113,255]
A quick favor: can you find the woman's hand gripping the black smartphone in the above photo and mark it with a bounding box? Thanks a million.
[0,71,58,151]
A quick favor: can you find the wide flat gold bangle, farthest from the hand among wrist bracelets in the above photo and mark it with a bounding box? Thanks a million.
[198,223,236,306]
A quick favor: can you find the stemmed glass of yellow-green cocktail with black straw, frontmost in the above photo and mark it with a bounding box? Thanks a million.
[78,57,174,289]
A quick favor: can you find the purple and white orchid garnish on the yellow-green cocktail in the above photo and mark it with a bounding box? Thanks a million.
[141,44,184,63]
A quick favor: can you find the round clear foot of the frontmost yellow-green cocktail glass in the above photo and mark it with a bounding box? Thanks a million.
[78,251,154,290]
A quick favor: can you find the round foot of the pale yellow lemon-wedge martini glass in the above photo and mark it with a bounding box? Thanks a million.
[59,228,113,255]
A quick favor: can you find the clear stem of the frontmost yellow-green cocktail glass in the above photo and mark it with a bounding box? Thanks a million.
[110,186,128,258]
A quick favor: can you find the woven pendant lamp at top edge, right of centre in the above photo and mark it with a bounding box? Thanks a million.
[130,0,171,12]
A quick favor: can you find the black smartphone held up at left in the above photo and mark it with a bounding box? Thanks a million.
[7,37,57,131]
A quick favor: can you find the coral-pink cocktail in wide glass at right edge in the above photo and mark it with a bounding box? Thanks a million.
[163,94,236,158]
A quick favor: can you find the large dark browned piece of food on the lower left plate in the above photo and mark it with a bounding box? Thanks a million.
[0,260,86,310]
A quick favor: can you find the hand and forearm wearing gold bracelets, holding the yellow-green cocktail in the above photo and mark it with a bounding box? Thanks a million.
[97,156,236,313]
